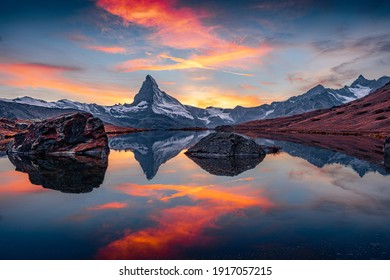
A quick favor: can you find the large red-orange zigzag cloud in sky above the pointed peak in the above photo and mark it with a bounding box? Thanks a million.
[97,0,271,76]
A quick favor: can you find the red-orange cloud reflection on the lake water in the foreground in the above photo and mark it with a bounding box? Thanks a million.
[97,184,274,259]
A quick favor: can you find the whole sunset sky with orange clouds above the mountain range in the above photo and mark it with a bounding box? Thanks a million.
[0,0,390,107]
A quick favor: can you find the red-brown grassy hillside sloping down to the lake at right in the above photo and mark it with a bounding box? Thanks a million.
[233,83,390,135]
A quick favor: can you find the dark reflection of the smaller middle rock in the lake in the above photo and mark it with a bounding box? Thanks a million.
[188,155,265,176]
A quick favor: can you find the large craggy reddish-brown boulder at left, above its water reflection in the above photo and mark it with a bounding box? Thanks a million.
[7,113,109,157]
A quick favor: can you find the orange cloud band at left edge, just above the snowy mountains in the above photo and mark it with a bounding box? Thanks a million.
[0,63,129,105]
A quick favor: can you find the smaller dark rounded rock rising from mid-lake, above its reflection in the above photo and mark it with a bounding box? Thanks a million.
[186,132,265,158]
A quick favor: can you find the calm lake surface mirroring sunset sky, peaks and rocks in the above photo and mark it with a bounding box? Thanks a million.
[0,132,390,259]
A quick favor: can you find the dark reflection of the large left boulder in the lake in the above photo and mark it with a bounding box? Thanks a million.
[8,154,108,193]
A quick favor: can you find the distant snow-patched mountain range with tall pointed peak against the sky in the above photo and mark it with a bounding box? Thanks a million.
[0,75,390,129]
